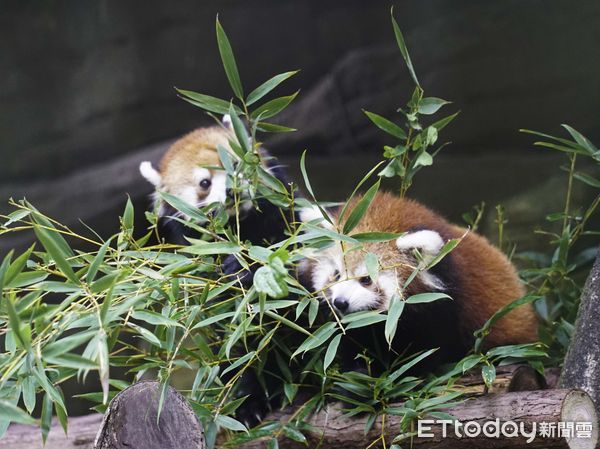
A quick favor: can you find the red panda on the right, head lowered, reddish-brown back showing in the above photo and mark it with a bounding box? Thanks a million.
[299,192,538,370]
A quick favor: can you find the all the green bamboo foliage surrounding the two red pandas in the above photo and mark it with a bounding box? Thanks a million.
[0,9,600,448]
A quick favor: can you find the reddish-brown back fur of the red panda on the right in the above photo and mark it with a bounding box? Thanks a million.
[347,192,538,346]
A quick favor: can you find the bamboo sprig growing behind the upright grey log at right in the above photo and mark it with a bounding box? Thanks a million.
[519,125,600,364]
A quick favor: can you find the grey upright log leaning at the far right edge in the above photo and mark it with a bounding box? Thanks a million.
[560,249,600,413]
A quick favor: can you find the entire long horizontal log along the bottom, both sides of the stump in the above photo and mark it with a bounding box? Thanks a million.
[0,384,598,449]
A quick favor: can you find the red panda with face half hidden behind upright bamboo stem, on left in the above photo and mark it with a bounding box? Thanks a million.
[140,115,299,262]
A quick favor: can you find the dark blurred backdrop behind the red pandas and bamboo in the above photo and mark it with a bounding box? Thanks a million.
[0,0,600,252]
